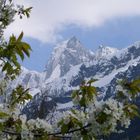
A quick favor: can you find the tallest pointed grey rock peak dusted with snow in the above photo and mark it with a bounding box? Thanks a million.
[46,37,93,79]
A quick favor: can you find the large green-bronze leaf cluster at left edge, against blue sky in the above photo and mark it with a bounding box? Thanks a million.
[0,32,31,80]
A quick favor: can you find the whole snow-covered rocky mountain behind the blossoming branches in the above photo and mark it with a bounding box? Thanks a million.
[21,37,140,118]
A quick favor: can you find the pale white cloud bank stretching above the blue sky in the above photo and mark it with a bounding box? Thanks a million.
[5,0,140,42]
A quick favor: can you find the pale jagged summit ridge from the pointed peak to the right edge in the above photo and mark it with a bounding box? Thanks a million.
[46,36,140,80]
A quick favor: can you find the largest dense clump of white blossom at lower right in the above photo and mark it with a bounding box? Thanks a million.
[89,98,130,136]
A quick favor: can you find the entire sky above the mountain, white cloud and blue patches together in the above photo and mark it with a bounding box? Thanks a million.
[5,0,140,71]
